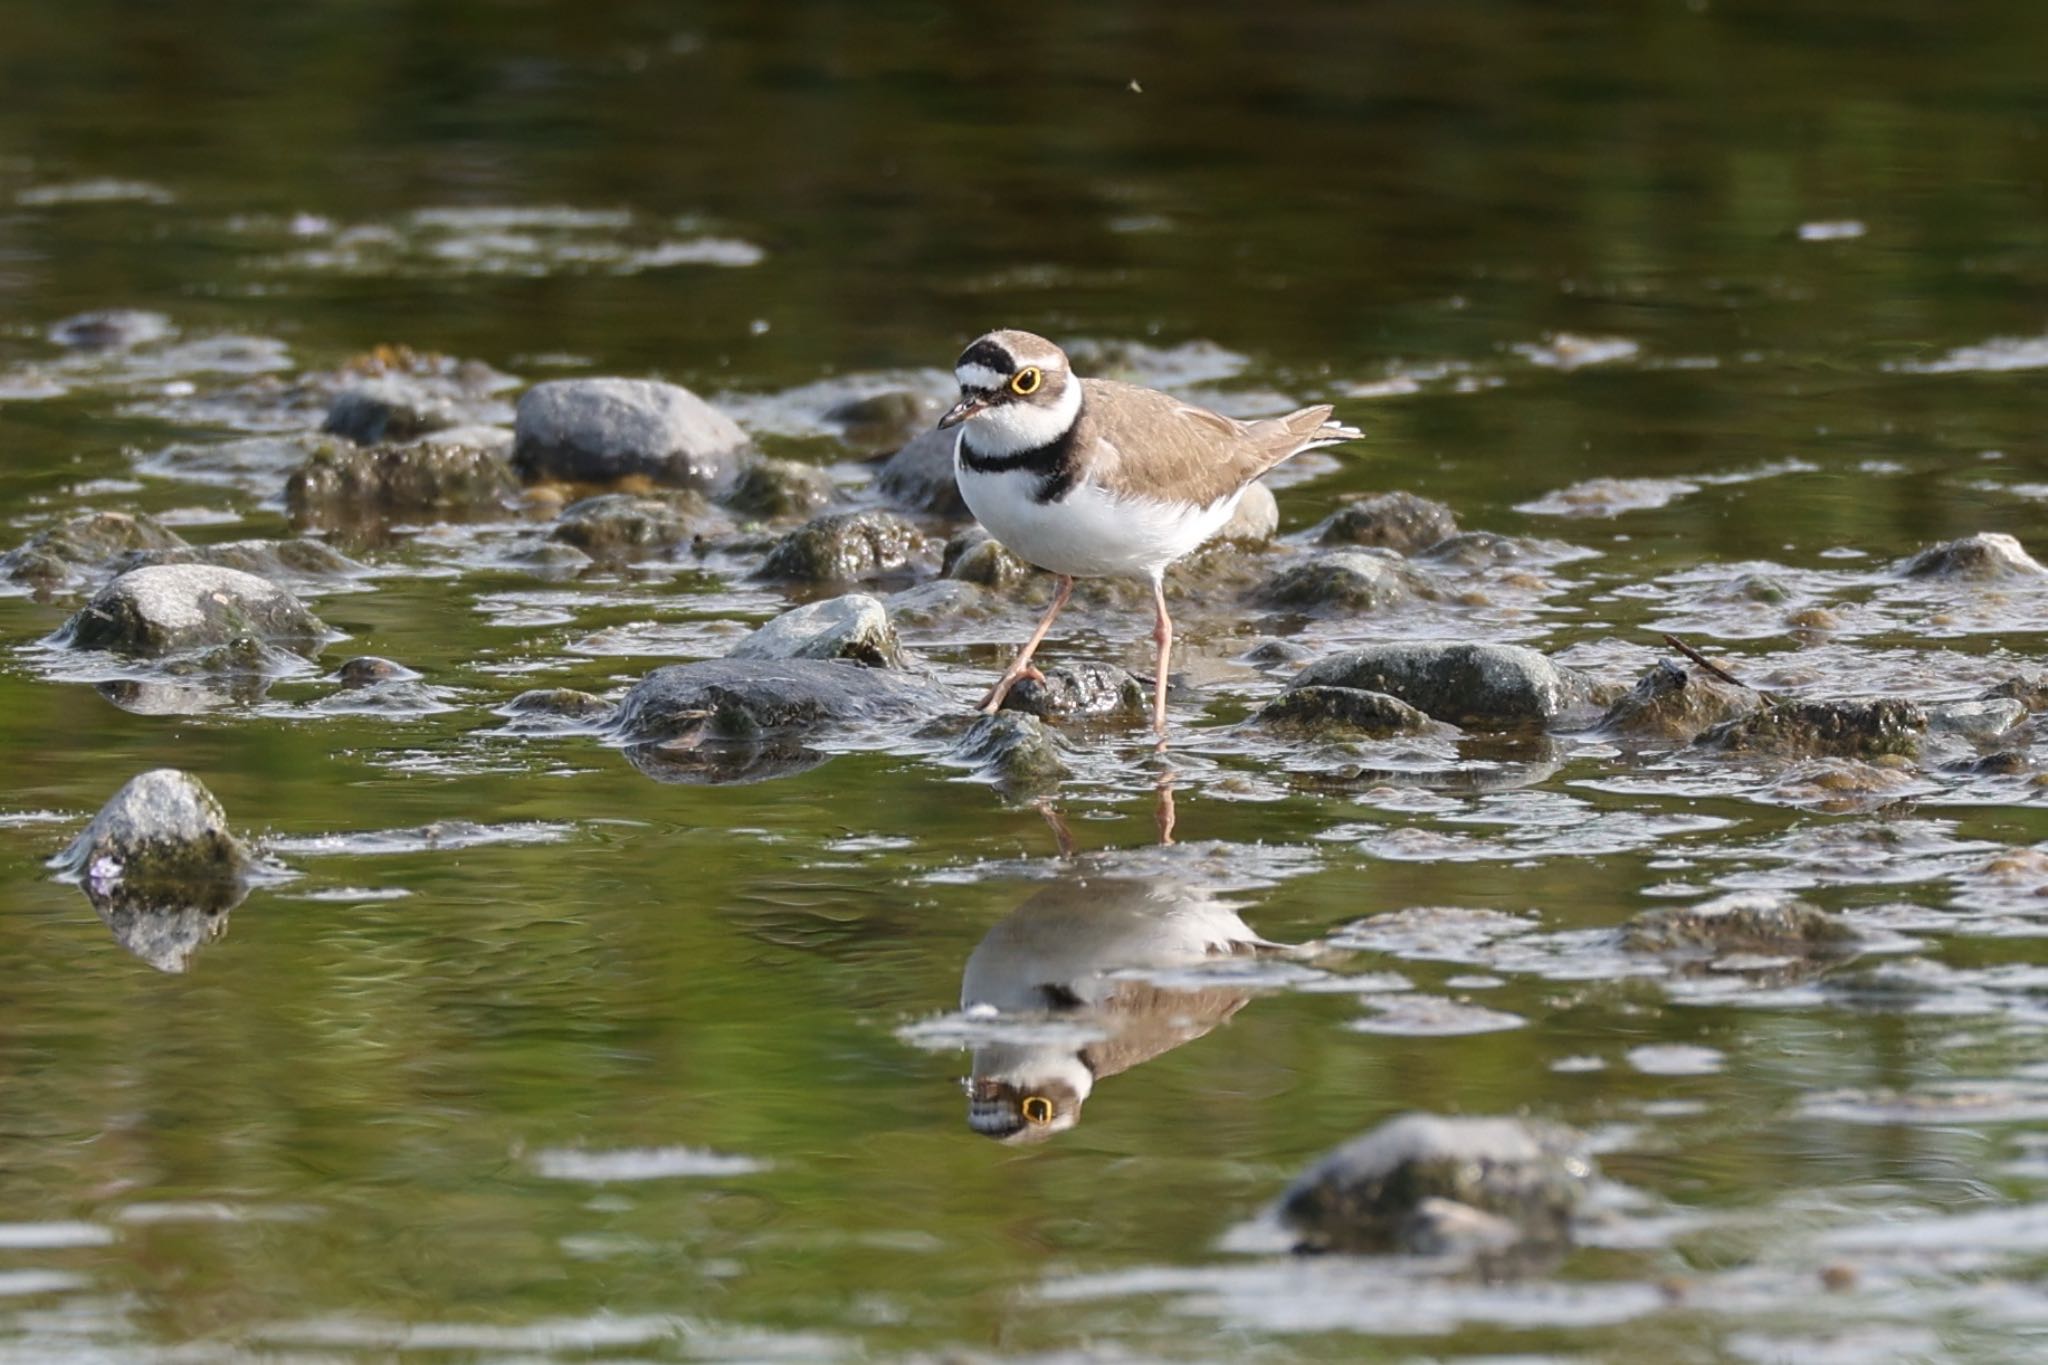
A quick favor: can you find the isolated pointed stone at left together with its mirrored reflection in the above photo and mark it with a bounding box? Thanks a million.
[49,767,252,972]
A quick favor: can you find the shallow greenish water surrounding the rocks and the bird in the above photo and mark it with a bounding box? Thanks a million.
[0,0,2048,1361]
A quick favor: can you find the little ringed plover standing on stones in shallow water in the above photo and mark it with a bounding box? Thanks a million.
[938,332,1364,743]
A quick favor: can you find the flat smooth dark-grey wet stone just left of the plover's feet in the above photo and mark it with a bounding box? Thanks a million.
[606,659,952,745]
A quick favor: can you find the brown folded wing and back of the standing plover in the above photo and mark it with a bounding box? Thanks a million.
[1075,379,1331,505]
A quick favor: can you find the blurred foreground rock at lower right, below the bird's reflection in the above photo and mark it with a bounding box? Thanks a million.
[1278,1113,1595,1254]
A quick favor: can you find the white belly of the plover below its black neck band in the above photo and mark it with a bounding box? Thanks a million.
[952,448,1243,579]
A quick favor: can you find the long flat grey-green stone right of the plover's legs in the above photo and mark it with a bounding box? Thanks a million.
[1290,641,1593,724]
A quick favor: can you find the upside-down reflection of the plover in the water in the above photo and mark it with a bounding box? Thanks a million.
[961,782,1300,1142]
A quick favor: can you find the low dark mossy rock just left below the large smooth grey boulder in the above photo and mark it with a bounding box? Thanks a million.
[285,442,518,526]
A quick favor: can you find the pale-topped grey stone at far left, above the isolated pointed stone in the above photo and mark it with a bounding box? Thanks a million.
[57,565,326,657]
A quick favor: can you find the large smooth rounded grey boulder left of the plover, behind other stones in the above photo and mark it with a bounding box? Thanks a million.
[512,379,750,489]
